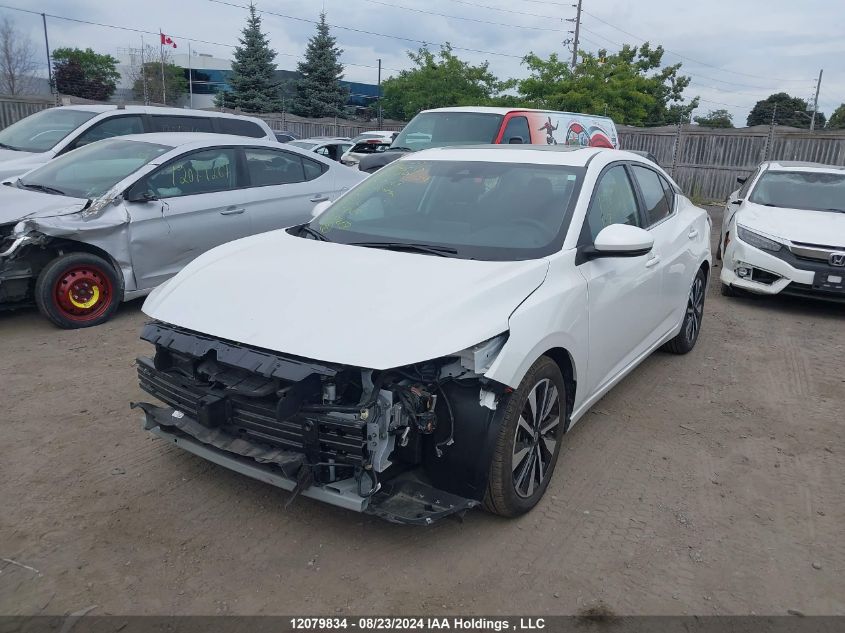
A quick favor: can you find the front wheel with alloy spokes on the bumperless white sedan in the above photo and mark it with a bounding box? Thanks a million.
[484,356,567,517]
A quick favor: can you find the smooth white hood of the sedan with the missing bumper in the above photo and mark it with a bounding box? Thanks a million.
[143,231,548,369]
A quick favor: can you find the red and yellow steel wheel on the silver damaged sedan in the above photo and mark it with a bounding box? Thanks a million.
[35,253,123,329]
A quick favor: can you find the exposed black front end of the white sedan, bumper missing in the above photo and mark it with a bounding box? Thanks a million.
[133,322,509,524]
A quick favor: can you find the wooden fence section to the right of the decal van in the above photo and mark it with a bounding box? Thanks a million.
[619,125,845,200]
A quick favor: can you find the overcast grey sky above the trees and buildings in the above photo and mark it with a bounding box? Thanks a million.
[0,0,845,125]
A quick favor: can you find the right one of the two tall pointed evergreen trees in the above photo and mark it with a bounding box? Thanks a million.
[292,13,349,117]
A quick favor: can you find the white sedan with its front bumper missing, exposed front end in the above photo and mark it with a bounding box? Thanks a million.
[134,145,710,523]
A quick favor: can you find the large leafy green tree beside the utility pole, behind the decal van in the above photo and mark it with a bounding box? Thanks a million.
[517,42,698,125]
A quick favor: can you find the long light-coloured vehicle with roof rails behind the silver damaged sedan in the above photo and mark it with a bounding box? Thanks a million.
[0,105,276,179]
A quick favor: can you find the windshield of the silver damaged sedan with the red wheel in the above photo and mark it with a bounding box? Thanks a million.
[18,138,173,198]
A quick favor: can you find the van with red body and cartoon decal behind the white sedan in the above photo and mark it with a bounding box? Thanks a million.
[358,106,619,173]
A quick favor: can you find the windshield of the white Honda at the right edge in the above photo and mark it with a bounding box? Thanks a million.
[748,171,845,211]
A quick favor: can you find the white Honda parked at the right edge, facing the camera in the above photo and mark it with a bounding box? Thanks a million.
[719,162,845,301]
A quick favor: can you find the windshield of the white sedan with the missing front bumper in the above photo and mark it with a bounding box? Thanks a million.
[309,160,584,260]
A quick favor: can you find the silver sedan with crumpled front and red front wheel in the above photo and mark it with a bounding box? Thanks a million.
[0,133,365,328]
